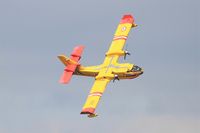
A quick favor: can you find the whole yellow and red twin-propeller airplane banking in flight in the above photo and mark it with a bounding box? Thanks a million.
[58,14,144,118]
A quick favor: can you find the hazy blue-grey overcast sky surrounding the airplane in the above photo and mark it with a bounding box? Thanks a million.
[0,0,200,133]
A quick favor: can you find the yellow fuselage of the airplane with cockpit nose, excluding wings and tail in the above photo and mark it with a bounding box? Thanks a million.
[74,55,143,80]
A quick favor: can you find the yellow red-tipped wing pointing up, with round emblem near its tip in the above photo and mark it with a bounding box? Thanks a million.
[106,15,137,61]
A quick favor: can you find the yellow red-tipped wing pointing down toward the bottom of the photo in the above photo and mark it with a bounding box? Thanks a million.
[81,79,110,116]
